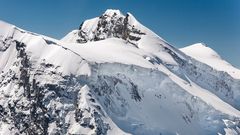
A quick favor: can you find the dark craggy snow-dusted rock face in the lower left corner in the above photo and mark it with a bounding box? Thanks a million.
[0,41,110,135]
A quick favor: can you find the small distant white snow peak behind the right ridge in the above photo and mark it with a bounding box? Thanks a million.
[180,43,240,79]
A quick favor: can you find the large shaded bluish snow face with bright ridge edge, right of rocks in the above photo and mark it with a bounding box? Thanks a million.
[89,64,240,134]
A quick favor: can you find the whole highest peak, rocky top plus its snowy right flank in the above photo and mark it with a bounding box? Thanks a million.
[61,9,180,65]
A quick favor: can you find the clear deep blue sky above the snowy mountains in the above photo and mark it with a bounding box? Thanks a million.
[0,0,240,68]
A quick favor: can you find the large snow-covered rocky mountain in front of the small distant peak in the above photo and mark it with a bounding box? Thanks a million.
[0,9,240,135]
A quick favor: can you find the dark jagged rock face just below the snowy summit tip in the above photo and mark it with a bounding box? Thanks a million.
[77,11,146,44]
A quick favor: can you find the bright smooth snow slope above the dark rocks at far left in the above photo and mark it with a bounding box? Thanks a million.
[0,22,89,74]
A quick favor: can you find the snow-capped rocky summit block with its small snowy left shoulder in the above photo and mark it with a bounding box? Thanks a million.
[63,9,152,44]
